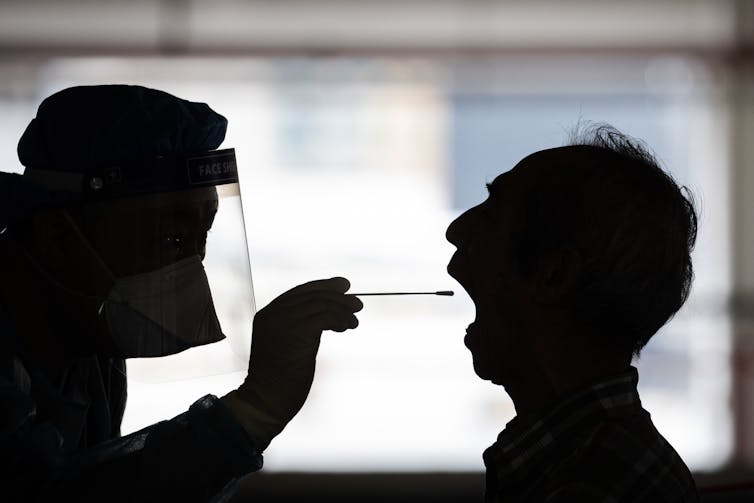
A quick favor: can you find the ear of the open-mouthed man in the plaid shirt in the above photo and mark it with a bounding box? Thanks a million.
[534,248,584,305]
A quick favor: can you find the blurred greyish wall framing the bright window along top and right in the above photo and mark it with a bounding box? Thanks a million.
[0,0,754,496]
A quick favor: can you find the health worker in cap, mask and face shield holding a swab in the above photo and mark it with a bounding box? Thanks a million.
[0,85,361,502]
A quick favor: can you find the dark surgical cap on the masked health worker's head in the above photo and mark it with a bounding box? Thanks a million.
[18,85,228,173]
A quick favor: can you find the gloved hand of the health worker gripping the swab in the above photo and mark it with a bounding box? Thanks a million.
[222,278,363,451]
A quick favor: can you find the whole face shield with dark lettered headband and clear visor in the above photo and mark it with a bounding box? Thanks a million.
[24,149,255,382]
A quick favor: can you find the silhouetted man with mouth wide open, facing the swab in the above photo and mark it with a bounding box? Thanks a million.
[447,125,697,502]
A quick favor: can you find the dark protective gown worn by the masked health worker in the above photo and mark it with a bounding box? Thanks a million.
[0,307,262,502]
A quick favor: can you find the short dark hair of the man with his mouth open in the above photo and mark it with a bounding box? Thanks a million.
[519,124,697,355]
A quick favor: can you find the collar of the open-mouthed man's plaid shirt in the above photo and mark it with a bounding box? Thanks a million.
[483,367,642,484]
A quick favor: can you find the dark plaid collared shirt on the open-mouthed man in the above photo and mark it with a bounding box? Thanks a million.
[483,367,699,503]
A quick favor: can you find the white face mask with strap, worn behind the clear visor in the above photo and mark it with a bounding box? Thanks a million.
[65,214,225,358]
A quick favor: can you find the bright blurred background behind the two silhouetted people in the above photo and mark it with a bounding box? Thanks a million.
[0,0,754,501]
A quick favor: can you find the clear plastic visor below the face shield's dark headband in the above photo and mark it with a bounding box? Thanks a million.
[94,183,255,383]
